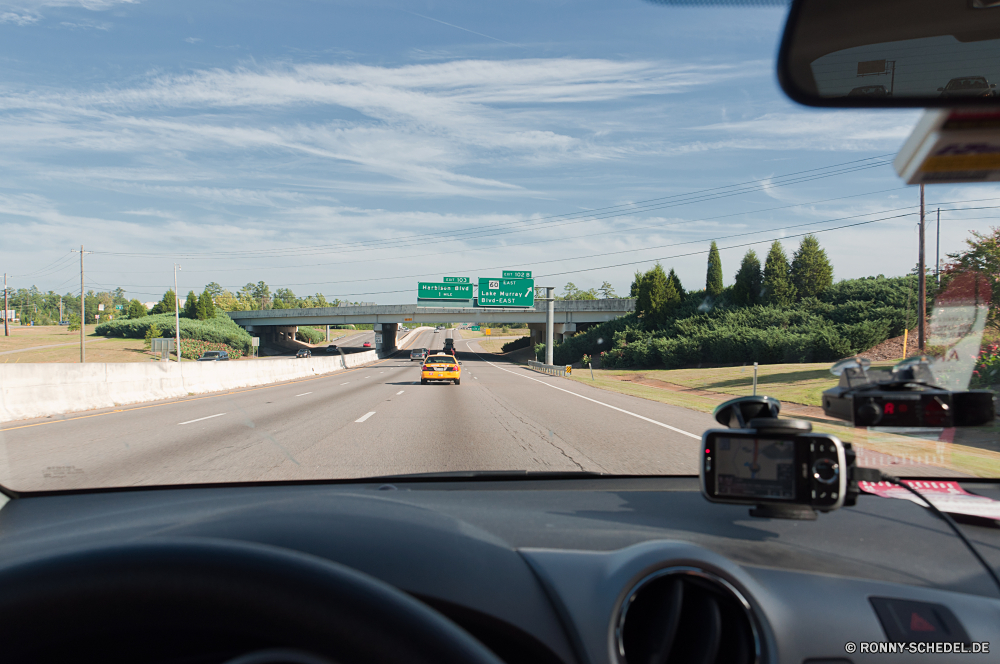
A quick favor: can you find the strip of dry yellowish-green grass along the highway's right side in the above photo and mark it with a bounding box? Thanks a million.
[568,368,1000,477]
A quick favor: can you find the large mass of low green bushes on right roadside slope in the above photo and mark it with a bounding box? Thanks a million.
[553,276,916,368]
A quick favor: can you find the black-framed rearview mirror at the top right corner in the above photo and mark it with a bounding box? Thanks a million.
[778,0,1000,107]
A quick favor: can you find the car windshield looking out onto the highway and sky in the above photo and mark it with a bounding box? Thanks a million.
[0,0,1000,491]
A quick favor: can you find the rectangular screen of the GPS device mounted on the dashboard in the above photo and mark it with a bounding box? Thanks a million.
[715,437,795,500]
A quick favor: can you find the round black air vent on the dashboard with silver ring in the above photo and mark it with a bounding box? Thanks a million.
[617,567,760,664]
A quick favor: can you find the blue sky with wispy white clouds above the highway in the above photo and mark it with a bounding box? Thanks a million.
[0,0,1000,303]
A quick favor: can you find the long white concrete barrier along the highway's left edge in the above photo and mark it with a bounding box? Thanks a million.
[0,351,380,422]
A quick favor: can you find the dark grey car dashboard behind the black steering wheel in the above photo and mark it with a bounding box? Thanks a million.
[0,477,1000,664]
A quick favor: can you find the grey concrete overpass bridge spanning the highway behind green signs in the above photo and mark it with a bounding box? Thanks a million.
[229,298,635,352]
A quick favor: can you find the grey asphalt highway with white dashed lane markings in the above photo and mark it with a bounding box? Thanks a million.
[0,330,715,491]
